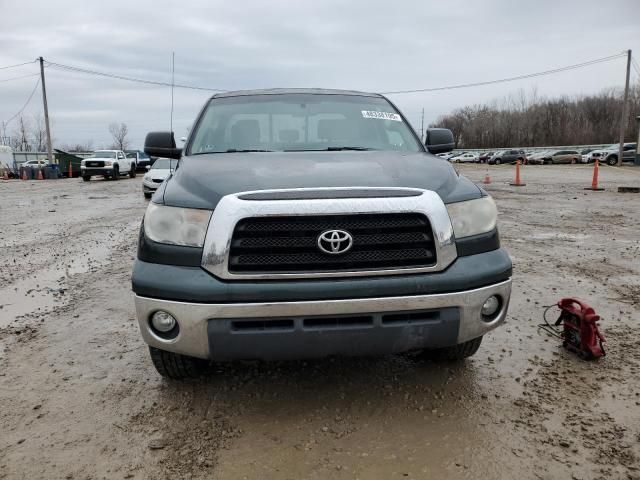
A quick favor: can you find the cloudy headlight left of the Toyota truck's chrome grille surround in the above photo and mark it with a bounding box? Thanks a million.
[144,203,212,247]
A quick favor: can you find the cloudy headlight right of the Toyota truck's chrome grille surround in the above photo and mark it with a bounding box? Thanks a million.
[447,197,498,238]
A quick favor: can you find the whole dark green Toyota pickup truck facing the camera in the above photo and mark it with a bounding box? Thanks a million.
[132,89,511,378]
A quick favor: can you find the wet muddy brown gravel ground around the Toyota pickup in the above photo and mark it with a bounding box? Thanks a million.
[0,165,640,480]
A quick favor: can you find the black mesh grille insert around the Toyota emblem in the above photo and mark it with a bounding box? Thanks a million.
[228,213,436,274]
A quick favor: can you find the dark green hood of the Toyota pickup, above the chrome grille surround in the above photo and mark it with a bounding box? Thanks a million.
[162,151,483,210]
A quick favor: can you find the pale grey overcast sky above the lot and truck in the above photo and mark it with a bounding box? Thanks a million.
[0,0,640,148]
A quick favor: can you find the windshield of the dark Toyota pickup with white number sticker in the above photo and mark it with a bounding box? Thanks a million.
[189,94,424,155]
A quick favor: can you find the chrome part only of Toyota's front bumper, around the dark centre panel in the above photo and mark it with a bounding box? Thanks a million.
[135,279,511,358]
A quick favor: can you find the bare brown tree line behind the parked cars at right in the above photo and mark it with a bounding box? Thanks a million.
[430,82,640,149]
